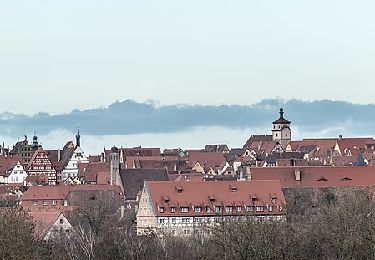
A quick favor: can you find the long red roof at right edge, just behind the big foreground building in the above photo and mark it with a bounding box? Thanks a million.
[250,166,375,188]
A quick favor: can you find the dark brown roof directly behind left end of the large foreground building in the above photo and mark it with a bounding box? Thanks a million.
[120,169,169,200]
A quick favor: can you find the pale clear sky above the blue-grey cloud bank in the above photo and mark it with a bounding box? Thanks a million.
[0,0,375,114]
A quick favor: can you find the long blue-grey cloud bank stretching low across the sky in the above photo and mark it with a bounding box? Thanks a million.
[0,99,375,137]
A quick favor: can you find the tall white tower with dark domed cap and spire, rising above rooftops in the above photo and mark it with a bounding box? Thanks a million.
[272,108,292,149]
